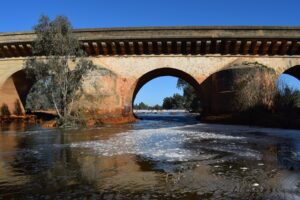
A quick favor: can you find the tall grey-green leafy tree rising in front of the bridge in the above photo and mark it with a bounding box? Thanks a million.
[24,16,96,126]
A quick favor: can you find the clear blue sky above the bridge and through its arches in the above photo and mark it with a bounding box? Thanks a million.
[0,0,300,105]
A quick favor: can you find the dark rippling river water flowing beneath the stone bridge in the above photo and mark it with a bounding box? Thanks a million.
[0,114,300,200]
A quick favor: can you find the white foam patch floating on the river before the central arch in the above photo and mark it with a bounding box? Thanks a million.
[71,127,259,161]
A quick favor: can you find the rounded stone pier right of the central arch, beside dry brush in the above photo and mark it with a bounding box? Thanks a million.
[200,63,279,115]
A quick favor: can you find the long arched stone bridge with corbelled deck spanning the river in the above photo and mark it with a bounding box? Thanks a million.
[0,27,300,122]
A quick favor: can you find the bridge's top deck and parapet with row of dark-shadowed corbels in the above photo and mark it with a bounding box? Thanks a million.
[0,26,300,58]
